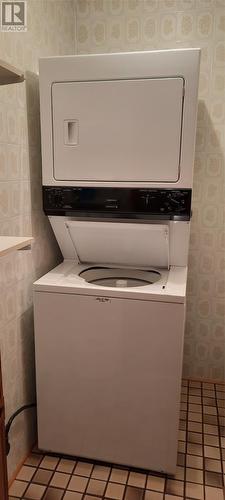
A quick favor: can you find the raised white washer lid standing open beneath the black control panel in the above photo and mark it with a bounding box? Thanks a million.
[66,220,169,268]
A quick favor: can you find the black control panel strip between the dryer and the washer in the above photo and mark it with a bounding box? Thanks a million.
[43,186,191,220]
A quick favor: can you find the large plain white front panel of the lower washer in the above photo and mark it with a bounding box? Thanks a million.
[34,292,185,473]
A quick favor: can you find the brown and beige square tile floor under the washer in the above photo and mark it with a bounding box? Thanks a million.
[9,380,225,500]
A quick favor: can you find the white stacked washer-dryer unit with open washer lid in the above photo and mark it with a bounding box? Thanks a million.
[34,49,200,473]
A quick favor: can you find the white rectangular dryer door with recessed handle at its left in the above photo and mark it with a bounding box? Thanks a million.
[52,77,184,183]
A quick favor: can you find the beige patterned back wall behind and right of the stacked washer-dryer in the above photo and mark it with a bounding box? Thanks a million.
[76,0,225,379]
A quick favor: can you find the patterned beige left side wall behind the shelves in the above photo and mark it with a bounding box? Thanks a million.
[0,0,75,482]
